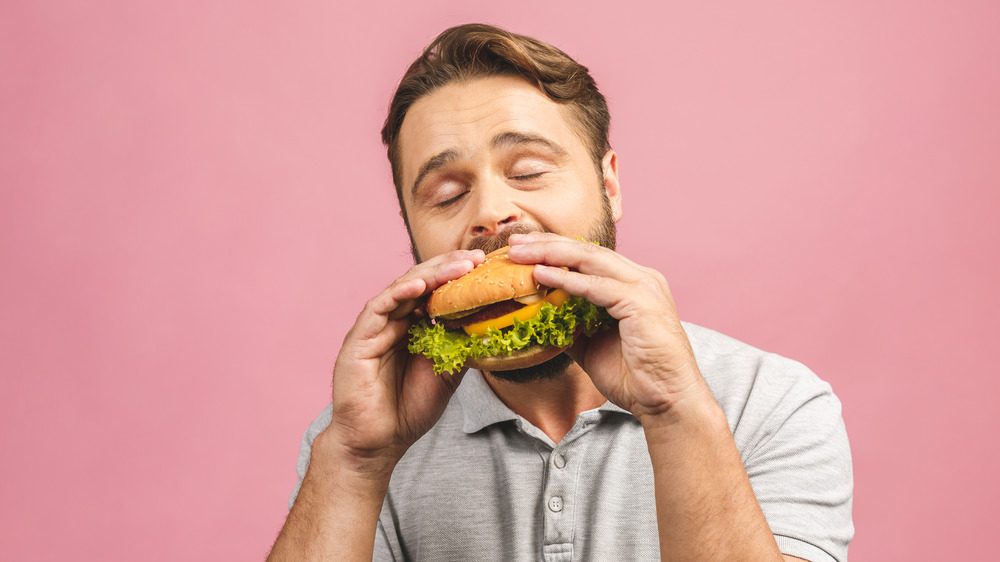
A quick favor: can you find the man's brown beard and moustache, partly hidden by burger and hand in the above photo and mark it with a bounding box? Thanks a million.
[466,190,617,384]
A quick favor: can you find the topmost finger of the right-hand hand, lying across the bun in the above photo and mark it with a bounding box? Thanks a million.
[508,233,642,282]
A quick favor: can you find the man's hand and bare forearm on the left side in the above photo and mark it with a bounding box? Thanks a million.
[268,250,485,561]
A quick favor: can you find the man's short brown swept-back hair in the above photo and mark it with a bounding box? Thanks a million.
[382,24,611,210]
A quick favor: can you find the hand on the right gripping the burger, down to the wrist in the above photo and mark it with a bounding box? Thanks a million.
[510,232,708,421]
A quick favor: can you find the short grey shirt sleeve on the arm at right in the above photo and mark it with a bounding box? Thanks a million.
[734,355,854,562]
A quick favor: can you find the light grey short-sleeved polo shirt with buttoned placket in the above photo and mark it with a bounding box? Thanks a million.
[289,323,854,562]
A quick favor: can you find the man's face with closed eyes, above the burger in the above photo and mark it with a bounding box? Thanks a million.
[399,73,621,260]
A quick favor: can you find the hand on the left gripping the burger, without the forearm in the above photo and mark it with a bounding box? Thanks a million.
[314,250,485,482]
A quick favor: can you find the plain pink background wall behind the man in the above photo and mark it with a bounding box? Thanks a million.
[0,0,1000,561]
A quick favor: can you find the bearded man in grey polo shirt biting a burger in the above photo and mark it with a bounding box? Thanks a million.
[271,25,853,560]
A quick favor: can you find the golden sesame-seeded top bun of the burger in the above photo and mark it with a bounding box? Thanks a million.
[427,246,542,317]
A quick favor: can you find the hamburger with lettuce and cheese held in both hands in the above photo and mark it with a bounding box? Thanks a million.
[409,247,609,374]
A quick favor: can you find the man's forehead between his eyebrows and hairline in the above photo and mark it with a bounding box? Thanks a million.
[399,76,586,186]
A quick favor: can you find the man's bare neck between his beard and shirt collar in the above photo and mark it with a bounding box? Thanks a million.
[483,363,607,443]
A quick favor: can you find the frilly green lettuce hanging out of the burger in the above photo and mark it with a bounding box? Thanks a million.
[408,296,610,375]
